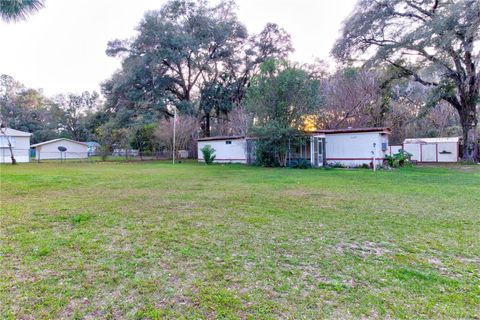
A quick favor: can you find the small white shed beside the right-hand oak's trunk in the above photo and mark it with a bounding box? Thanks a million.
[403,137,460,162]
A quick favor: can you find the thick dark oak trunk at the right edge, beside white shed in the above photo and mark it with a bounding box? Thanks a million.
[459,104,479,161]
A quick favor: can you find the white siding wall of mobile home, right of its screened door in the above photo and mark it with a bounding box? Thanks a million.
[325,132,388,166]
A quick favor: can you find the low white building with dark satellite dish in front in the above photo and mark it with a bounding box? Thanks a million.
[30,138,89,160]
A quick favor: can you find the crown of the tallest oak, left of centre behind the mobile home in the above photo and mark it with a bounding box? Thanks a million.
[103,0,247,134]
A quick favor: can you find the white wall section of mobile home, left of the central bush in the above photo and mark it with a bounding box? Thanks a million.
[198,139,247,163]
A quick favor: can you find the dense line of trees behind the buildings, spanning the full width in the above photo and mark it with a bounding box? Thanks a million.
[0,0,480,160]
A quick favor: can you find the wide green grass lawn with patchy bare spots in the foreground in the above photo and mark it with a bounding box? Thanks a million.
[0,162,480,319]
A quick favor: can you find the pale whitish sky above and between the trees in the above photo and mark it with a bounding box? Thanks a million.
[0,0,356,95]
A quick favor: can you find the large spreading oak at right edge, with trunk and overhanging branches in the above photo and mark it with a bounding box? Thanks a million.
[333,0,480,160]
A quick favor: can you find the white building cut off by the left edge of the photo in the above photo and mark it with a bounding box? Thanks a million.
[0,128,32,163]
